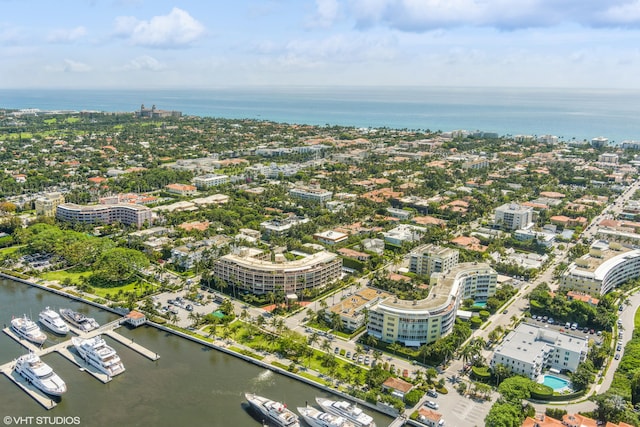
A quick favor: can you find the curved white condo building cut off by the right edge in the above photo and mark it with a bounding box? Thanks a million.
[560,240,640,295]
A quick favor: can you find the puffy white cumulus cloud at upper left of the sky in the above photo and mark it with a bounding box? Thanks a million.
[115,7,205,48]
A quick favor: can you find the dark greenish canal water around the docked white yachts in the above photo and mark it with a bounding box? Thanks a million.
[0,279,391,427]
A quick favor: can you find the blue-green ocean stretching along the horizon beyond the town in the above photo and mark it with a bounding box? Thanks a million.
[0,87,640,144]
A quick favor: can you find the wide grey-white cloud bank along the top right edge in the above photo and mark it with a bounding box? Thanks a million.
[349,0,640,32]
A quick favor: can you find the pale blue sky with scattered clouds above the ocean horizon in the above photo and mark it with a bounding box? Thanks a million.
[0,0,640,89]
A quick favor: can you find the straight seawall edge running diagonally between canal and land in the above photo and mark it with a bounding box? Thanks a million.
[0,271,402,418]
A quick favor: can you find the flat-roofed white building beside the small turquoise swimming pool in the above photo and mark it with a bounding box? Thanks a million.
[490,323,589,381]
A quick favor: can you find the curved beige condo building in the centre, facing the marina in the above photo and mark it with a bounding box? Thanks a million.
[213,248,342,294]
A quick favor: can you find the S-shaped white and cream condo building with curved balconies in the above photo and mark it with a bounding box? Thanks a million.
[367,262,498,347]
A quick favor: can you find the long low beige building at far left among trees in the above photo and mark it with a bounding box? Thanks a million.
[56,203,153,228]
